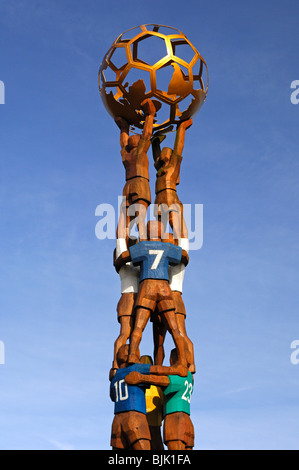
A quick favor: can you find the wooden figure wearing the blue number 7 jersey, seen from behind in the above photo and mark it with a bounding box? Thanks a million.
[115,221,189,366]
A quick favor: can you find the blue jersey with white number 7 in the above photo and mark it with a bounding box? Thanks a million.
[130,241,183,282]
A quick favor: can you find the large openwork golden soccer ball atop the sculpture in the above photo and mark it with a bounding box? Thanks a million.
[99,24,208,130]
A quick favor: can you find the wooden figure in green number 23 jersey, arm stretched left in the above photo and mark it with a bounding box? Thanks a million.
[125,350,194,450]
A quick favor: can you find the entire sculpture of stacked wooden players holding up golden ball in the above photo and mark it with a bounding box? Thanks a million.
[99,24,208,450]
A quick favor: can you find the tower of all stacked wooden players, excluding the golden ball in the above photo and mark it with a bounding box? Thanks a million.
[109,99,195,450]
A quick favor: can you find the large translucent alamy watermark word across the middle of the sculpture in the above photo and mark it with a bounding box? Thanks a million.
[95,196,203,250]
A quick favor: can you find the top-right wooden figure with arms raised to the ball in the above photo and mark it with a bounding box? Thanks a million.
[152,119,192,239]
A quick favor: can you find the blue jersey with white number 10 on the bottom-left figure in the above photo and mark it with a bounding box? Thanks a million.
[110,364,151,415]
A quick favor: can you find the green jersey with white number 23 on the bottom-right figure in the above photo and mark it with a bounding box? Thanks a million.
[163,372,193,416]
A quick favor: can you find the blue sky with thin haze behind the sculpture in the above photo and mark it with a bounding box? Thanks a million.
[0,0,299,449]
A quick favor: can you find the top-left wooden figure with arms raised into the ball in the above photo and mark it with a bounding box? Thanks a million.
[115,99,156,240]
